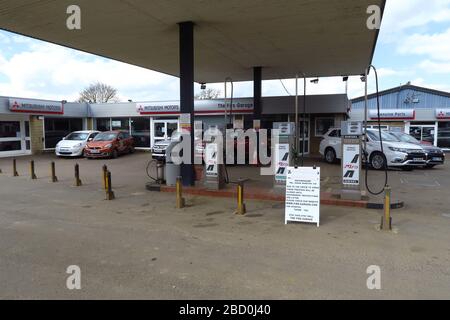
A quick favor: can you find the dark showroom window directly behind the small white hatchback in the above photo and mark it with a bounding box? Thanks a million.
[44,118,83,149]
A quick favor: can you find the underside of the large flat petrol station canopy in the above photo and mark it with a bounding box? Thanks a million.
[0,0,385,83]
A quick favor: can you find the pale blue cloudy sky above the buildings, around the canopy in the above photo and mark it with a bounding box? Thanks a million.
[0,0,450,101]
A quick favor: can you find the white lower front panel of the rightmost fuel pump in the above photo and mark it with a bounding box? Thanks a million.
[342,144,361,186]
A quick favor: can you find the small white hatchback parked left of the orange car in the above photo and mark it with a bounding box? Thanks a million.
[55,131,100,157]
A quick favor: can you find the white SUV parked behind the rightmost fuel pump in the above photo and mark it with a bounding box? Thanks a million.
[319,129,426,170]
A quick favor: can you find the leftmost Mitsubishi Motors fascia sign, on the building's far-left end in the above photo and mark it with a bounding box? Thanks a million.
[9,98,64,114]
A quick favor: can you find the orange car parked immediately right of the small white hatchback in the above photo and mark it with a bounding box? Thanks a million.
[84,131,134,158]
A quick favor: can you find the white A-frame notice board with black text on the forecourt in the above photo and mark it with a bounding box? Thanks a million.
[285,167,320,226]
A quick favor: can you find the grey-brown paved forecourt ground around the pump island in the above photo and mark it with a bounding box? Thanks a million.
[0,153,450,299]
